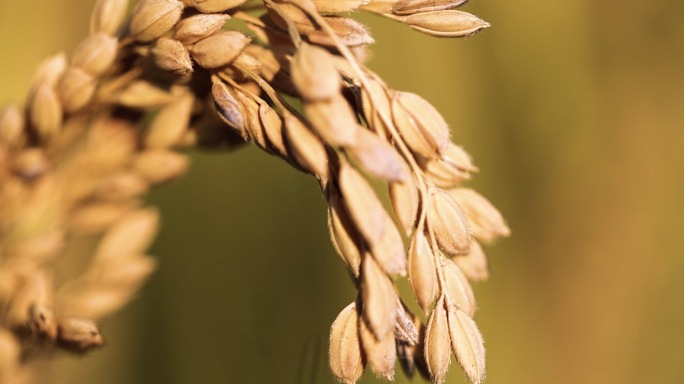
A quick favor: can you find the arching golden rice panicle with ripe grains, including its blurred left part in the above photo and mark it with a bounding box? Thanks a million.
[0,0,508,383]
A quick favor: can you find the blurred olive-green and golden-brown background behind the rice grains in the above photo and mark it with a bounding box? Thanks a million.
[0,0,684,384]
